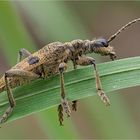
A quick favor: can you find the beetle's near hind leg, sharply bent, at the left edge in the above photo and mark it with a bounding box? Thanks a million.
[0,69,39,123]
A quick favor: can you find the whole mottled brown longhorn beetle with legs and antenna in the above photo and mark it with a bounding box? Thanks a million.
[0,18,140,125]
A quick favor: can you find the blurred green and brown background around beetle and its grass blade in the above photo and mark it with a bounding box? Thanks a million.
[0,1,140,139]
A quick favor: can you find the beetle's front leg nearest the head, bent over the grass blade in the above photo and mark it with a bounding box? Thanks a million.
[76,57,110,105]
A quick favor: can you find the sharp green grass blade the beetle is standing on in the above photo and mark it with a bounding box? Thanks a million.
[0,57,140,122]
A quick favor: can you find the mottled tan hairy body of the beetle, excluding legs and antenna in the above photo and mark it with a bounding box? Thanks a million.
[0,40,115,92]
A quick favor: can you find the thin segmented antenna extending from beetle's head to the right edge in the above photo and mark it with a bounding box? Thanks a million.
[107,18,140,43]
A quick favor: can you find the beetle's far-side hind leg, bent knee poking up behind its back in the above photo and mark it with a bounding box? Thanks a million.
[17,49,31,62]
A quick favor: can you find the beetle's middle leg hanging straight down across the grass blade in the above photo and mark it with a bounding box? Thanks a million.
[58,62,71,125]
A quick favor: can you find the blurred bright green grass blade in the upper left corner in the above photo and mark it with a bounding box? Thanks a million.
[0,1,35,64]
